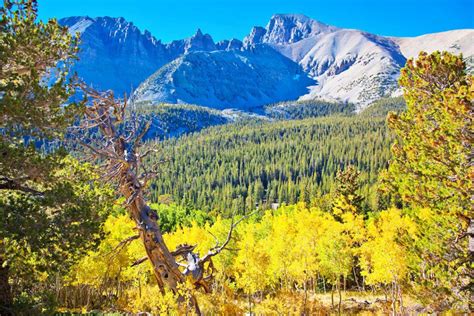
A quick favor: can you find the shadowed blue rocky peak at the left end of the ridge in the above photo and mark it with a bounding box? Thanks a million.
[59,17,169,95]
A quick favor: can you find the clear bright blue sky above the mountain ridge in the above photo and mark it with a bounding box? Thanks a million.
[39,0,474,42]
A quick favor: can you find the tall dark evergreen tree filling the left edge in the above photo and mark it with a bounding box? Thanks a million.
[0,0,111,315]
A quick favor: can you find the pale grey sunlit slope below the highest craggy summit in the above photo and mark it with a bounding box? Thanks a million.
[299,30,405,107]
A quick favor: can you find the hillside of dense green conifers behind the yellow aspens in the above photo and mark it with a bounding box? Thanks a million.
[148,116,394,214]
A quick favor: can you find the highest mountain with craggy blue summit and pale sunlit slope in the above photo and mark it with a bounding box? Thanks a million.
[244,14,405,106]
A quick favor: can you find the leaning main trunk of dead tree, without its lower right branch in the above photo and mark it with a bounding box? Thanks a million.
[81,89,206,315]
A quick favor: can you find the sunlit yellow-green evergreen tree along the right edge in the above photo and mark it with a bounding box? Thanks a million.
[384,52,474,309]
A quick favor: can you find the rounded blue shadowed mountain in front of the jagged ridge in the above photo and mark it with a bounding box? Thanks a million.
[133,46,313,110]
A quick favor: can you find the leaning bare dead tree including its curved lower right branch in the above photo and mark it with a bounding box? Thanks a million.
[74,85,251,315]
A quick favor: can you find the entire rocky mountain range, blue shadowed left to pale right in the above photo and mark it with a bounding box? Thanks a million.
[60,14,474,110]
